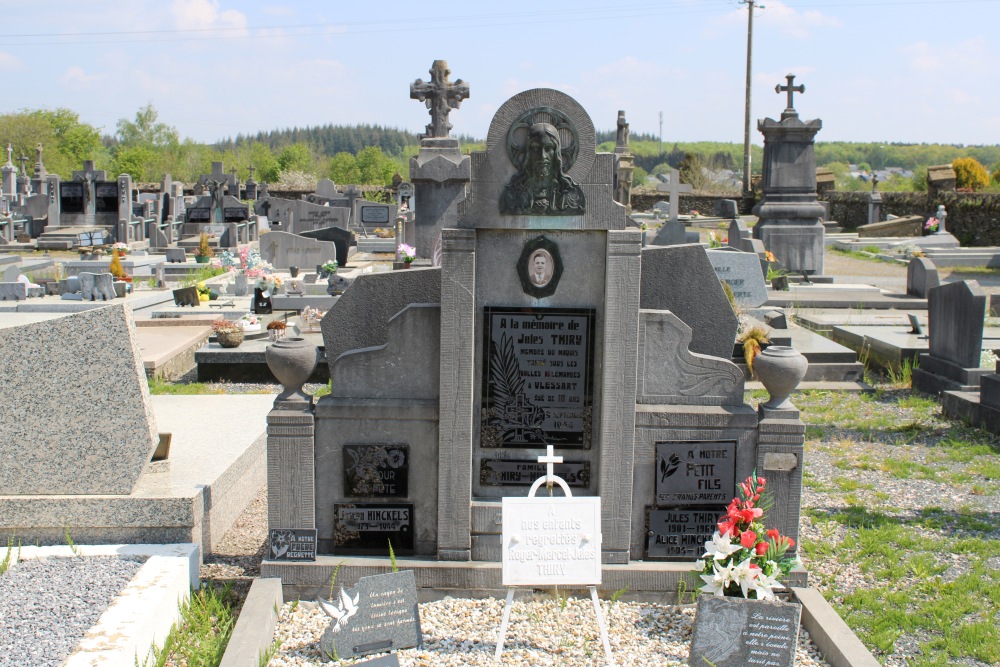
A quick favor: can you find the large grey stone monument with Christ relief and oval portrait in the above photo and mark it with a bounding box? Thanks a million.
[262,89,805,596]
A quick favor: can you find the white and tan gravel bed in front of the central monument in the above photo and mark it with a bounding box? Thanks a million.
[268,594,828,667]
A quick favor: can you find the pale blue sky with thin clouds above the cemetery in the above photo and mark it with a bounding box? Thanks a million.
[0,0,1000,144]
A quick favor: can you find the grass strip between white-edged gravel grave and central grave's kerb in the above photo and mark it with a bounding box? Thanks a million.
[146,583,238,667]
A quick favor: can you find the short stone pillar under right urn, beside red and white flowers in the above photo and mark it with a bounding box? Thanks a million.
[756,404,806,553]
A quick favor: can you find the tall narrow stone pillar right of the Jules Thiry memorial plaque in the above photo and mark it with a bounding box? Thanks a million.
[596,230,642,564]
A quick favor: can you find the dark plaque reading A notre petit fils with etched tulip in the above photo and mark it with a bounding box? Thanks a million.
[656,442,736,507]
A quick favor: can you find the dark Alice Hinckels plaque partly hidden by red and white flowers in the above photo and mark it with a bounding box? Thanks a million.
[646,505,726,561]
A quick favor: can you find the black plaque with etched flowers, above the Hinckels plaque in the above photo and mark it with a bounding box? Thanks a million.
[344,445,410,498]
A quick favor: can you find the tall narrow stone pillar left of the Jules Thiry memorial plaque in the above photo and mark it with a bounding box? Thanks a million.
[436,227,474,561]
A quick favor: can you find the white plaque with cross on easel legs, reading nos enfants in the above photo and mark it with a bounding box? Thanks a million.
[496,445,612,665]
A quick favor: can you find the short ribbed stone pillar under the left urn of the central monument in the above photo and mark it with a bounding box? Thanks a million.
[267,403,316,529]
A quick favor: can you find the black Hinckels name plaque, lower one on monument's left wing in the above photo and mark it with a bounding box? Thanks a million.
[333,503,414,556]
